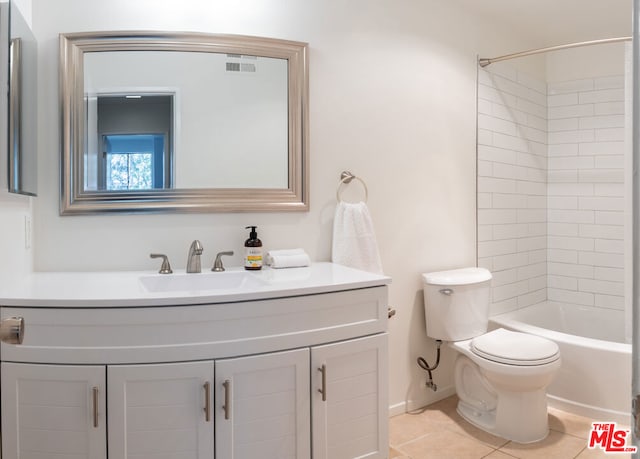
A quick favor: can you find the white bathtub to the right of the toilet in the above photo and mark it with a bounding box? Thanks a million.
[489,302,631,425]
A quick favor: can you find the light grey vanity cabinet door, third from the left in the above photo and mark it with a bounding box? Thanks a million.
[215,349,311,459]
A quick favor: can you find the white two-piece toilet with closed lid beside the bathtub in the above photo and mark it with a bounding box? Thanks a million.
[422,268,560,443]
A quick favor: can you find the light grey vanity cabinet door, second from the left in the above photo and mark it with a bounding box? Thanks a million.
[107,361,214,459]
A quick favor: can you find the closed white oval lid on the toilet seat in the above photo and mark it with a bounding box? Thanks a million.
[471,328,560,366]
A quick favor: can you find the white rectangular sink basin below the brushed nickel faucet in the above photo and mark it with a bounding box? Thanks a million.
[140,271,266,292]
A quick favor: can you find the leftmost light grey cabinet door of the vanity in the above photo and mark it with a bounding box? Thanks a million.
[1,362,106,459]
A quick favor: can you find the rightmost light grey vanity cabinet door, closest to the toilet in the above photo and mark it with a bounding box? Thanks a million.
[311,333,389,459]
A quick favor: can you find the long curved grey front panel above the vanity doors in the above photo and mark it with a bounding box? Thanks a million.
[1,286,387,364]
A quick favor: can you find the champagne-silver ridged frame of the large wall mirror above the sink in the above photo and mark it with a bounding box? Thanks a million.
[60,31,309,215]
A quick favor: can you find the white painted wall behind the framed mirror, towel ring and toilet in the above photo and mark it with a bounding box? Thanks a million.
[28,0,544,416]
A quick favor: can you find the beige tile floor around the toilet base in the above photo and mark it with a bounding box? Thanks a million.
[389,396,631,459]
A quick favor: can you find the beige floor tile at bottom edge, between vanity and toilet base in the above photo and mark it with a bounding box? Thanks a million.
[402,430,494,459]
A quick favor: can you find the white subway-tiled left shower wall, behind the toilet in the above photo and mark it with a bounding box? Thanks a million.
[478,66,548,314]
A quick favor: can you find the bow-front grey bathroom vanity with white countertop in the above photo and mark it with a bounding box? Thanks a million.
[0,263,390,459]
